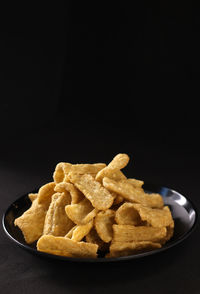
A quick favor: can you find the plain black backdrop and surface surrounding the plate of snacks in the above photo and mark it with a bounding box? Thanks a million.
[0,1,200,294]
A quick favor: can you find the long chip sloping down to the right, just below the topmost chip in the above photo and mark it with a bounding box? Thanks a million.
[103,177,164,208]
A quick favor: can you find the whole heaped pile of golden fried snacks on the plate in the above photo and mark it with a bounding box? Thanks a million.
[14,153,174,258]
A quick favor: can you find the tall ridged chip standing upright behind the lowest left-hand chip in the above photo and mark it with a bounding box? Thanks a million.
[43,193,74,236]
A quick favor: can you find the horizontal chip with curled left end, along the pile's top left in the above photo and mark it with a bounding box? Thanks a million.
[53,162,106,184]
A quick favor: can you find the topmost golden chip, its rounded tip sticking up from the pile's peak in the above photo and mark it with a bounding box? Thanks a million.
[95,153,129,182]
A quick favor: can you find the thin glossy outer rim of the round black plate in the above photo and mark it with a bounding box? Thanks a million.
[2,182,199,263]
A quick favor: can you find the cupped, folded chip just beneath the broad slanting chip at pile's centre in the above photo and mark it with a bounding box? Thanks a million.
[65,198,98,225]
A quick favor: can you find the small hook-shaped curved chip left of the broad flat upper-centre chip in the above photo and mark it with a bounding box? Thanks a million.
[54,182,84,204]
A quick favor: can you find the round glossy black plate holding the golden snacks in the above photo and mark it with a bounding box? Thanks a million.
[2,184,197,263]
